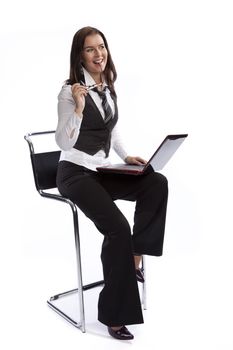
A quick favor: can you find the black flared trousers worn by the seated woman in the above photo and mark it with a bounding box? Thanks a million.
[57,161,168,326]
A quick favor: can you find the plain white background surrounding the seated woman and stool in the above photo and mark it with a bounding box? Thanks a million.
[0,0,233,350]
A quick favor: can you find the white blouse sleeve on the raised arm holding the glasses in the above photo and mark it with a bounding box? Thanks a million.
[55,85,82,151]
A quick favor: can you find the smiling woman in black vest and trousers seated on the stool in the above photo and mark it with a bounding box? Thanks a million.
[56,27,168,340]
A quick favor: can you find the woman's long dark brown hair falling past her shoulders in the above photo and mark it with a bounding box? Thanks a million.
[66,27,117,96]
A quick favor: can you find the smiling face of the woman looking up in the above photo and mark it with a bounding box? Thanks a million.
[82,34,108,77]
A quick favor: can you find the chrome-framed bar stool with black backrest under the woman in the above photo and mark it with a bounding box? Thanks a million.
[24,130,146,332]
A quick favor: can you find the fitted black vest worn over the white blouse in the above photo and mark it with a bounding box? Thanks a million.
[73,95,118,157]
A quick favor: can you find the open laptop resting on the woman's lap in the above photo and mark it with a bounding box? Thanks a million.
[96,134,188,175]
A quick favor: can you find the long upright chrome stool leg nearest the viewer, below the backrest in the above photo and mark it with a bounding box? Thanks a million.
[70,203,86,332]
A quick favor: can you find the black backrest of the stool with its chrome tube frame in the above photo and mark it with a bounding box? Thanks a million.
[24,131,61,191]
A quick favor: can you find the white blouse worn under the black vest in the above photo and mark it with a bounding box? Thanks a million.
[55,69,128,171]
